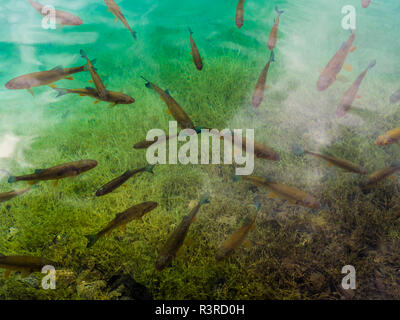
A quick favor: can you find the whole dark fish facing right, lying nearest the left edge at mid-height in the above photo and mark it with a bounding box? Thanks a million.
[8,160,97,186]
